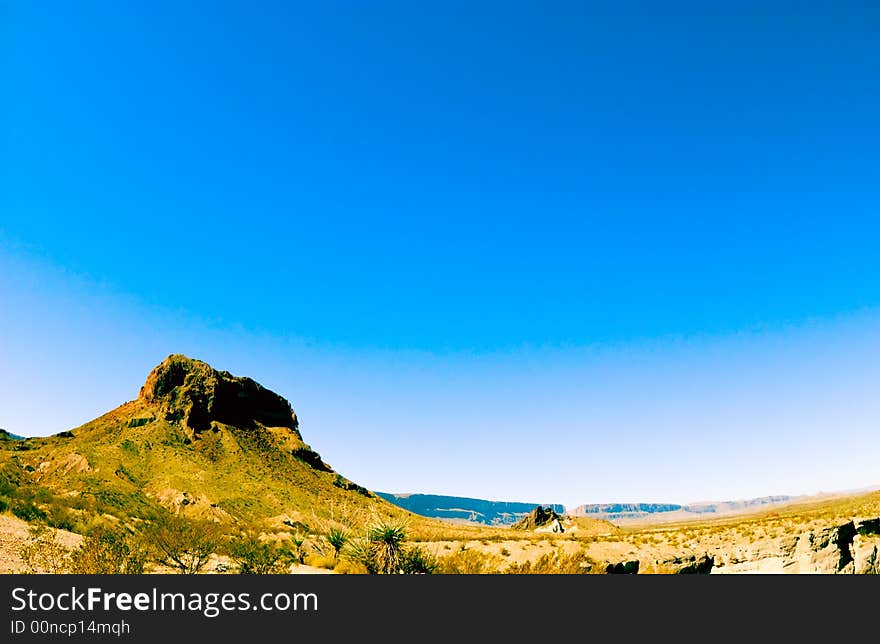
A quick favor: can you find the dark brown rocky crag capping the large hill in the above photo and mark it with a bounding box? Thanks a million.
[139,354,299,432]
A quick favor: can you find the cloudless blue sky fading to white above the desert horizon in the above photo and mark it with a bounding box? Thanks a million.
[0,1,880,505]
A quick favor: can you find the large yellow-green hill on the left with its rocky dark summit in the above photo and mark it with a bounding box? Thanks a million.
[0,355,406,527]
